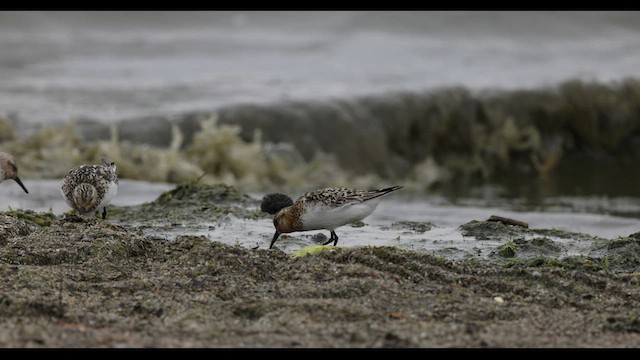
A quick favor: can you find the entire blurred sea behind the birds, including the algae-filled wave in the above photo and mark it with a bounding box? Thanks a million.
[0,11,640,238]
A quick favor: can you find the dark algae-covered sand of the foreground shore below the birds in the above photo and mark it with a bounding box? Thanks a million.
[0,184,640,347]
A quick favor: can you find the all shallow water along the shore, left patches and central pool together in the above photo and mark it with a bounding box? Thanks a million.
[5,180,640,259]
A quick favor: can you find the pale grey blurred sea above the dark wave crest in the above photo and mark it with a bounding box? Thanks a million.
[0,11,640,123]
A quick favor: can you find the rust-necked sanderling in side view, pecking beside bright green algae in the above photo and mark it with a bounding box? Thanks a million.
[269,186,403,249]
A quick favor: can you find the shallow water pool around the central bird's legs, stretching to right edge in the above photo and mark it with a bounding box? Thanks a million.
[176,200,640,253]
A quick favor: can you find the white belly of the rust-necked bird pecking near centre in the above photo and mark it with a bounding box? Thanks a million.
[302,199,379,230]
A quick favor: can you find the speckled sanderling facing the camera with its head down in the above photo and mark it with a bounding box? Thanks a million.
[60,159,118,219]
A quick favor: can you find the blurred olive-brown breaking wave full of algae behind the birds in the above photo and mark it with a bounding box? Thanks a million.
[7,79,640,200]
